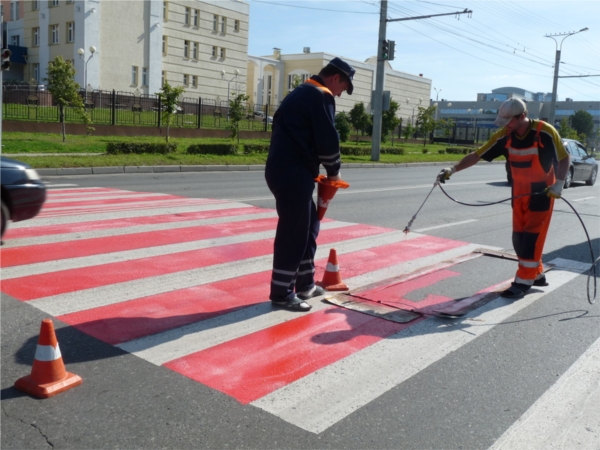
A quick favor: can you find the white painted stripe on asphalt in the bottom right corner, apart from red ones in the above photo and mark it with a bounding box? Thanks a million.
[490,339,600,450]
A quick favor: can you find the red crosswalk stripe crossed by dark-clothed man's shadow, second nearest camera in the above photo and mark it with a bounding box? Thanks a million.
[58,236,466,345]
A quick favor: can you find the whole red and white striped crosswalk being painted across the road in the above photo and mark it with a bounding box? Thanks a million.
[1,187,587,433]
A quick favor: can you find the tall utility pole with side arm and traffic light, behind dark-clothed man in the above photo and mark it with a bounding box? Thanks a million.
[371,4,473,161]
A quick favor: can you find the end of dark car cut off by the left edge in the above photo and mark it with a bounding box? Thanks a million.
[0,156,46,236]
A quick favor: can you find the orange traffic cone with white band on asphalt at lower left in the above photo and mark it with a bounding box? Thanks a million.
[15,319,83,398]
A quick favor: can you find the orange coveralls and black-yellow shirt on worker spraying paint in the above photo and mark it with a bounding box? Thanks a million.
[477,120,567,286]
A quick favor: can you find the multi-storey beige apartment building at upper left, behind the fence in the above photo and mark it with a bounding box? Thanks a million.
[2,0,249,96]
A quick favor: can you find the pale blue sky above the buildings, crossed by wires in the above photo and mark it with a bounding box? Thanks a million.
[247,0,600,101]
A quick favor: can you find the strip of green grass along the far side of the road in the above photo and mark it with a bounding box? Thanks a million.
[2,132,463,169]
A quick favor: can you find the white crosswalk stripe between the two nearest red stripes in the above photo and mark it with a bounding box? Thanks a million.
[118,242,481,365]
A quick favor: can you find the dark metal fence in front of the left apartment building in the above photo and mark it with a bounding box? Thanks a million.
[2,85,277,131]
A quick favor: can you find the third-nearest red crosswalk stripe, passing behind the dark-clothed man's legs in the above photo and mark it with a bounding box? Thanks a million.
[2,225,389,301]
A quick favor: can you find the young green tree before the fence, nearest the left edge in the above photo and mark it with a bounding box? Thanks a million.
[44,56,93,142]
